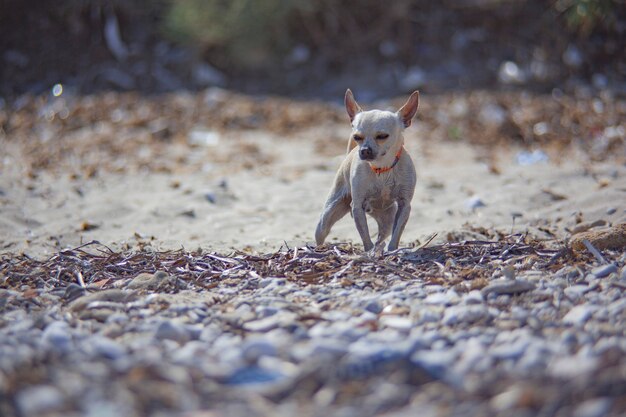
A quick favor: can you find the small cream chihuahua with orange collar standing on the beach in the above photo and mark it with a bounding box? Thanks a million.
[315,89,419,251]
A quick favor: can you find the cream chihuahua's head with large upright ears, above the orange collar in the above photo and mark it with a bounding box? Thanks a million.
[345,89,419,162]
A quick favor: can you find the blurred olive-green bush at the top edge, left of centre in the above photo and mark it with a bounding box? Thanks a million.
[166,0,308,68]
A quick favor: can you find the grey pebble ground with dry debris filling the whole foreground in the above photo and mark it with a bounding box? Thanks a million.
[0,242,626,417]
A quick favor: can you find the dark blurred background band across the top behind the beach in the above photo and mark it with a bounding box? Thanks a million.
[0,0,626,100]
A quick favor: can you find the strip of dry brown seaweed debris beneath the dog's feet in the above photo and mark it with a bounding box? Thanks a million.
[0,235,567,289]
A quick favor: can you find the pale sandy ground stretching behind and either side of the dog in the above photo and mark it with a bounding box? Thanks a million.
[0,118,626,256]
